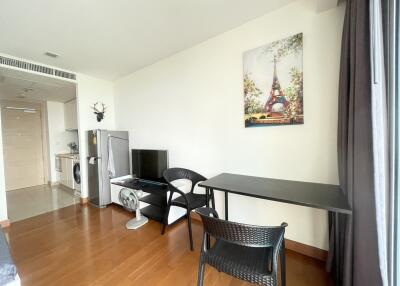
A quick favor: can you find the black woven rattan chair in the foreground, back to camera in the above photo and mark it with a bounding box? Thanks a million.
[196,208,287,286]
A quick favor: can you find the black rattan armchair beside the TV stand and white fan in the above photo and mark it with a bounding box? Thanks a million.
[161,168,215,250]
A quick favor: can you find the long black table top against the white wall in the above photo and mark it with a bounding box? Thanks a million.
[199,173,351,214]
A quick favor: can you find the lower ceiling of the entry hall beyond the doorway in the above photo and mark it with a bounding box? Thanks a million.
[0,67,76,102]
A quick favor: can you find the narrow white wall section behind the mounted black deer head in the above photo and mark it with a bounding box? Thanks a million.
[77,74,115,198]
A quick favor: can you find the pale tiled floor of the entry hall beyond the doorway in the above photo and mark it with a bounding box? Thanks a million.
[6,185,79,222]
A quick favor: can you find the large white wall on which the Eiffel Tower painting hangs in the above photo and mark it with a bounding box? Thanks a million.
[115,0,344,249]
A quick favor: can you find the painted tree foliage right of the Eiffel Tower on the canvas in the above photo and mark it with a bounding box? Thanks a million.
[285,68,303,119]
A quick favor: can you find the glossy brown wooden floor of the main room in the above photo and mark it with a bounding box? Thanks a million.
[6,205,333,286]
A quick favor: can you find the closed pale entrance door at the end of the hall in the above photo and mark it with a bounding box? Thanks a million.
[1,101,45,191]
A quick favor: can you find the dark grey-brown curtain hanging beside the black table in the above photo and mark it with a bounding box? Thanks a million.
[327,0,384,286]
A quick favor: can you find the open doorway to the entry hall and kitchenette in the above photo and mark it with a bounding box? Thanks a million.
[0,67,80,222]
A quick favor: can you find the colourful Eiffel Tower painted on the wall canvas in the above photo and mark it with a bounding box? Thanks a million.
[265,57,289,117]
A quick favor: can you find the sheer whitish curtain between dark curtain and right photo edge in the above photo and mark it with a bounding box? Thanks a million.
[369,0,390,286]
